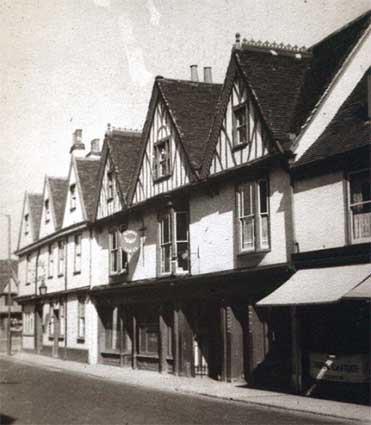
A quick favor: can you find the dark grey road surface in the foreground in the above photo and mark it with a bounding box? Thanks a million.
[0,358,347,425]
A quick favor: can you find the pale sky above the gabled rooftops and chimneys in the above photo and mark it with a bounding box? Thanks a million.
[0,0,370,258]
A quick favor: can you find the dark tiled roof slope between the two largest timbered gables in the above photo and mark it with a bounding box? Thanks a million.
[156,78,222,170]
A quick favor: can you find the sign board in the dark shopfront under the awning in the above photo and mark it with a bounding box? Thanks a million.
[309,353,370,383]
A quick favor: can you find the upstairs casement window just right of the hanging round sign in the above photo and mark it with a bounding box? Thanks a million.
[159,209,189,274]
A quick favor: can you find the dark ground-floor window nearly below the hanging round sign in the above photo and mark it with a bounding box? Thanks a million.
[138,307,159,356]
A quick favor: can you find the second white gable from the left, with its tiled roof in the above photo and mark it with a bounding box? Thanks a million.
[40,176,68,239]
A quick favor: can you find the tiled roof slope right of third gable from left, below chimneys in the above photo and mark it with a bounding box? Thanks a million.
[76,158,100,221]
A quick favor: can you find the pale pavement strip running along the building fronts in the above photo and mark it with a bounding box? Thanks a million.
[0,352,371,424]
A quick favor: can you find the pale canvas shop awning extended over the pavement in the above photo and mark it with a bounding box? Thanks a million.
[257,264,371,306]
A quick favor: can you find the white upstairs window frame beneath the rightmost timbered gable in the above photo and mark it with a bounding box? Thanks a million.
[236,178,271,253]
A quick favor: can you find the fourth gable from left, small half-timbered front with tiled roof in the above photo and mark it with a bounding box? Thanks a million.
[96,129,141,220]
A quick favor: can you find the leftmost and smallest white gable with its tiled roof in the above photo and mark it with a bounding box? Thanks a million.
[18,192,42,248]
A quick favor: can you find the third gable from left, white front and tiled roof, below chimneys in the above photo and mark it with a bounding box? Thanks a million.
[63,158,99,227]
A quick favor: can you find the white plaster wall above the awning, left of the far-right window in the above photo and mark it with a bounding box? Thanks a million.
[294,173,346,252]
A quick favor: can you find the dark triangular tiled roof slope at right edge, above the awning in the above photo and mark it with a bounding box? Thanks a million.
[294,72,371,167]
